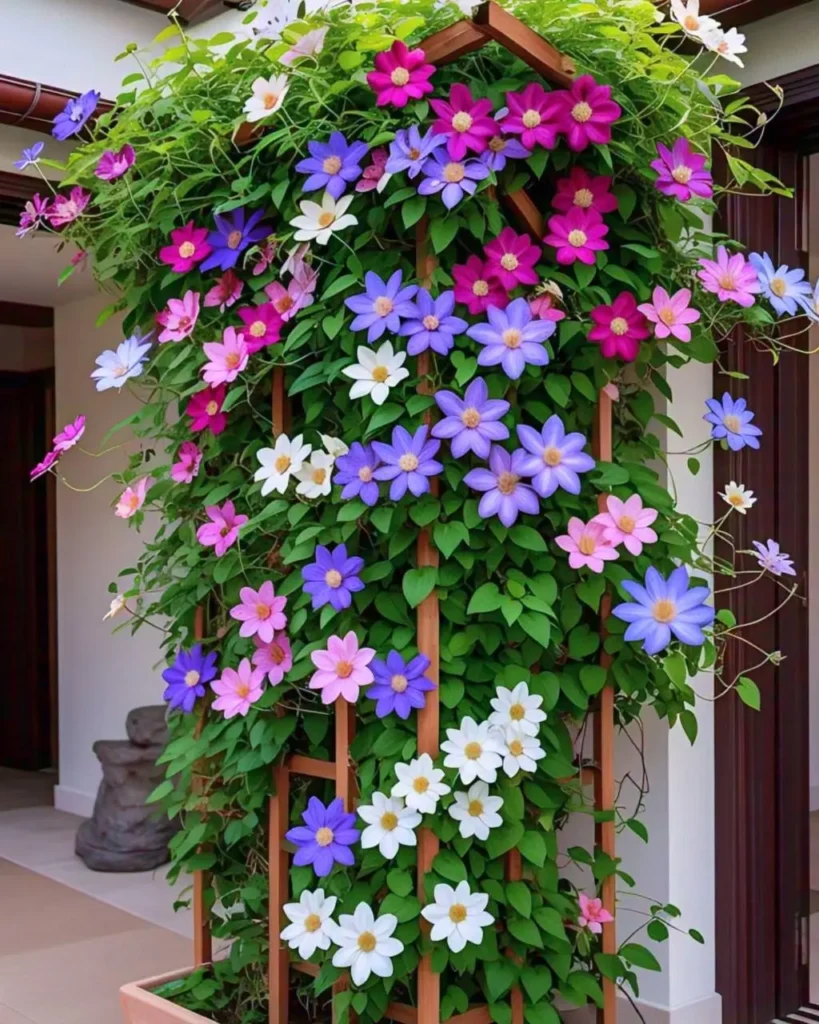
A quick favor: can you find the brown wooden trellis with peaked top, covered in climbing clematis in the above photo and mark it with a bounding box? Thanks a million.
[193,2,616,1024]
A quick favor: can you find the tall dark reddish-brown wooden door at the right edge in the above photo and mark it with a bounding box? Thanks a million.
[715,143,811,1024]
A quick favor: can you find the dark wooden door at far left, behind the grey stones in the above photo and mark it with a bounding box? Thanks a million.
[0,371,53,769]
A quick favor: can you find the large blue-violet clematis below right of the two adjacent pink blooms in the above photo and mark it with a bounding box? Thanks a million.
[612,565,714,654]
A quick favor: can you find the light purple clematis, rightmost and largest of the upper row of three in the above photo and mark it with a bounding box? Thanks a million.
[467,298,557,381]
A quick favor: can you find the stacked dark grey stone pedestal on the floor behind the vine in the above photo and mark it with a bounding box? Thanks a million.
[75,706,179,871]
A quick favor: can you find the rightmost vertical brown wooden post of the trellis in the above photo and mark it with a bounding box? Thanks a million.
[593,391,617,1024]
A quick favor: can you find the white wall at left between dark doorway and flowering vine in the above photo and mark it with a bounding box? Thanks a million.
[54,297,163,814]
